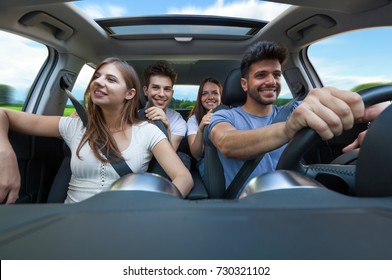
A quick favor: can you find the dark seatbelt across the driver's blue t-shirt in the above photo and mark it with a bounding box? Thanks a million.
[224,96,299,199]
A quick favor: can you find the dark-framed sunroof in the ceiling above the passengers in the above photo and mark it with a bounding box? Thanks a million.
[96,15,267,39]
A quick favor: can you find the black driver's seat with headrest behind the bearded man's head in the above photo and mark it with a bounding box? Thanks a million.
[203,68,246,198]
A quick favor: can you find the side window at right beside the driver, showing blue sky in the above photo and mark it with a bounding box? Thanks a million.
[308,27,392,91]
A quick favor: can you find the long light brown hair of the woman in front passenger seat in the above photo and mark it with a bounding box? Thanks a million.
[76,57,140,162]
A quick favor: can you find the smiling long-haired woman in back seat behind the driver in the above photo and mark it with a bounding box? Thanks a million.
[187,77,222,178]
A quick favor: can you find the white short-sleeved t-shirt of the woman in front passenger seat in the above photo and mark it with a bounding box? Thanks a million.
[59,117,166,203]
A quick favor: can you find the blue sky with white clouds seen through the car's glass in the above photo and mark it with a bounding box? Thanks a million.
[0,0,392,103]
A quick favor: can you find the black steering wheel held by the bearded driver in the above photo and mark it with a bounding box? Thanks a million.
[276,85,392,193]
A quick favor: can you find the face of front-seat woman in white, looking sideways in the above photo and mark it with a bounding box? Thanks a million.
[90,63,136,109]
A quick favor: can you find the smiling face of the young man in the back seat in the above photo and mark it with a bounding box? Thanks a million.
[143,75,174,110]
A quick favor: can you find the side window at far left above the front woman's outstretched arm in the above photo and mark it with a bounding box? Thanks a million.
[0,31,48,110]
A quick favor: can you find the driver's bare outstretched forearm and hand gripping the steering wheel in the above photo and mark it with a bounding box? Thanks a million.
[211,87,364,160]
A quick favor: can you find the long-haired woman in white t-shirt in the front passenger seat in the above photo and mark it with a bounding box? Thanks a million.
[0,58,193,204]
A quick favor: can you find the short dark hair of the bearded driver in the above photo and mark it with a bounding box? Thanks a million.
[241,41,288,78]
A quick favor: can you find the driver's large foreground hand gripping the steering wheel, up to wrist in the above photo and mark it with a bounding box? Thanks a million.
[286,87,365,140]
